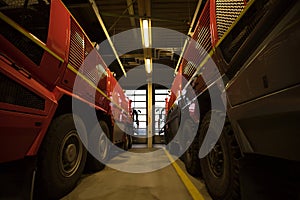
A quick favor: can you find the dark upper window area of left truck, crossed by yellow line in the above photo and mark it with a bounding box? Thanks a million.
[0,0,50,66]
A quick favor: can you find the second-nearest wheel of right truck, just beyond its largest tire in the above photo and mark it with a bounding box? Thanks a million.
[182,119,200,176]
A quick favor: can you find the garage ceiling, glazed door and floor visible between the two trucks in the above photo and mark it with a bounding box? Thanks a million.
[62,0,212,200]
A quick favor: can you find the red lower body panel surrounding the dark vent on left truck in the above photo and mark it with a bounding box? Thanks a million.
[0,57,57,162]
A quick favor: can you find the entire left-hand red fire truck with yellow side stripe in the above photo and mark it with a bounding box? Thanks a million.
[0,0,132,199]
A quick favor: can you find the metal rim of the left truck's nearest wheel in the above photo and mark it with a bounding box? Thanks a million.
[59,130,83,177]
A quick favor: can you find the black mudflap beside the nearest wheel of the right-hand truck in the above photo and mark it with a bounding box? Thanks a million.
[240,154,300,200]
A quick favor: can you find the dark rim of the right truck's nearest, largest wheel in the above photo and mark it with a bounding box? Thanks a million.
[208,142,224,177]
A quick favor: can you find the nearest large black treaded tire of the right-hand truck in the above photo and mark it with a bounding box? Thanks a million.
[199,111,241,200]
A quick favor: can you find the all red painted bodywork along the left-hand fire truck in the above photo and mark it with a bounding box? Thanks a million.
[0,0,132,163]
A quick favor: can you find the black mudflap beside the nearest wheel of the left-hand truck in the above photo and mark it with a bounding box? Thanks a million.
[0,157,37,200]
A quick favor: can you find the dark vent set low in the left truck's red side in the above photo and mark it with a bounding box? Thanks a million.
[0,73,45,110]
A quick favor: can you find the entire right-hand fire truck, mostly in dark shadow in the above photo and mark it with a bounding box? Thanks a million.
[165,0,300,200]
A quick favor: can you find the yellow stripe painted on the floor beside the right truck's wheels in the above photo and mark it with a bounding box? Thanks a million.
[164,149,204,200]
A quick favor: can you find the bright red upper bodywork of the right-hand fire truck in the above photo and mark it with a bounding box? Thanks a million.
[166,0,246,119]
